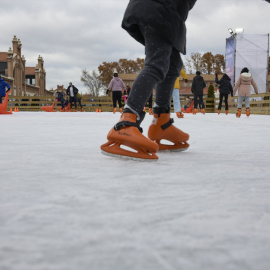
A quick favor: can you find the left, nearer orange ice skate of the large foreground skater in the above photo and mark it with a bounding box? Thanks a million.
[100,112,158,160]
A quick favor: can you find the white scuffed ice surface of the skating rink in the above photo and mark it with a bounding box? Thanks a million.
[0,112,270,270]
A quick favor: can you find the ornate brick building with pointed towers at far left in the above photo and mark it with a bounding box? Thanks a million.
[0,36,52,96]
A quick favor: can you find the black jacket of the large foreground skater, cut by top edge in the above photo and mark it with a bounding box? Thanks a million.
[122,0,197,54]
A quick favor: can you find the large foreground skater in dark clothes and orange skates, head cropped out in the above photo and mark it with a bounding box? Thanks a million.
[101,0,196,160]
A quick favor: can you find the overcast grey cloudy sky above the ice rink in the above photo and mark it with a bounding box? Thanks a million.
[0,0,270,92]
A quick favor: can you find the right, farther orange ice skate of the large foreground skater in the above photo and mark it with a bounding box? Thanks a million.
[148,107,189,151]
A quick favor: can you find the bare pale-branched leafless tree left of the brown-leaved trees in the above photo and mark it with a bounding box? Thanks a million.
[81,69,104,97]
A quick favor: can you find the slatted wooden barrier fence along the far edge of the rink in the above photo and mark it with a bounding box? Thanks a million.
[3,92,270,115]
